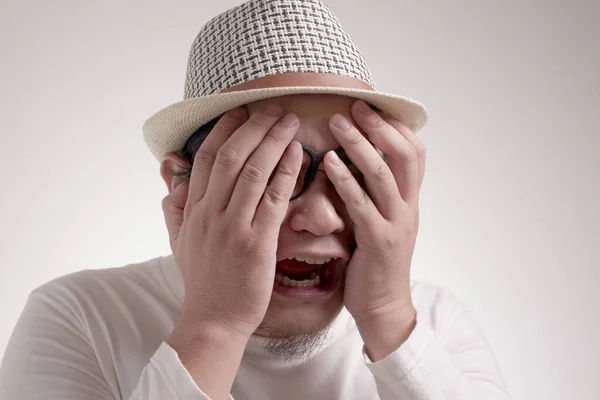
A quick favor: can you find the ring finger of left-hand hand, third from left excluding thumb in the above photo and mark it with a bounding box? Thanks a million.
[226,114,300,222]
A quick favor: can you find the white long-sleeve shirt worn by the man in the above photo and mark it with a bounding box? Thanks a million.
[0,255,509,400]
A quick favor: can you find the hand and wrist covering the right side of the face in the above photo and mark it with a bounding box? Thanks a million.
[325,101,425,358]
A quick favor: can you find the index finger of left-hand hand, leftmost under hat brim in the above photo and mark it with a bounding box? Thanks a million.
[188,107,248,204]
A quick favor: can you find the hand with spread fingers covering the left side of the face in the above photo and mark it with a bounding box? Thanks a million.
[163,105,302,338]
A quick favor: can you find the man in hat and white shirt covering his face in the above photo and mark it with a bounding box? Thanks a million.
[0,0,508,400]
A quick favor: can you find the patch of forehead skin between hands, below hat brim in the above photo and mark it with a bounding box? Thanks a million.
[246,94,356,151]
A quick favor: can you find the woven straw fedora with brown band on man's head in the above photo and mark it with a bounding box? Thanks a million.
[142,0,427,161]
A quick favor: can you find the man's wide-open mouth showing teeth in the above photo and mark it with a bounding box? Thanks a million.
[275,257,341,290]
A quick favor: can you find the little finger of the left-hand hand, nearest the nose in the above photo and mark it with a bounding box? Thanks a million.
[253,141,302,232]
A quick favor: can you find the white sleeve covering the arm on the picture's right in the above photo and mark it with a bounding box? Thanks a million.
[363,289,510,400]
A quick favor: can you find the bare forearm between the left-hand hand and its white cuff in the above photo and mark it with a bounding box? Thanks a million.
[167,319,248,400]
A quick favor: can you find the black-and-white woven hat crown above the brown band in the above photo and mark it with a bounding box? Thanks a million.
[184,0,375,99]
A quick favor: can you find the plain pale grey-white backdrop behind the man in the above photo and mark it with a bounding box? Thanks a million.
[0,0,600,400]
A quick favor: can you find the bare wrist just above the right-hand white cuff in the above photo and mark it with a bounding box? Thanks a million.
[356,305,417,362]
